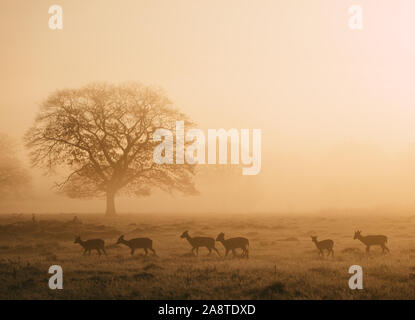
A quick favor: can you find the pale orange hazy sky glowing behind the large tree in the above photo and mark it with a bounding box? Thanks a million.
[0,0,415,212]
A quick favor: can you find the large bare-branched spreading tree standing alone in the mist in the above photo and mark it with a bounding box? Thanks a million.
[25,83,196,216]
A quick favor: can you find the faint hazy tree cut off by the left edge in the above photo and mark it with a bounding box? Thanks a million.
[0,134,30,200]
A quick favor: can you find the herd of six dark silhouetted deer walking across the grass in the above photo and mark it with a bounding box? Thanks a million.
[75,231,389,259]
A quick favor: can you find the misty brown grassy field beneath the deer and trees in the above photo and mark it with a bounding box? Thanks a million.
[0,213,415,299]
